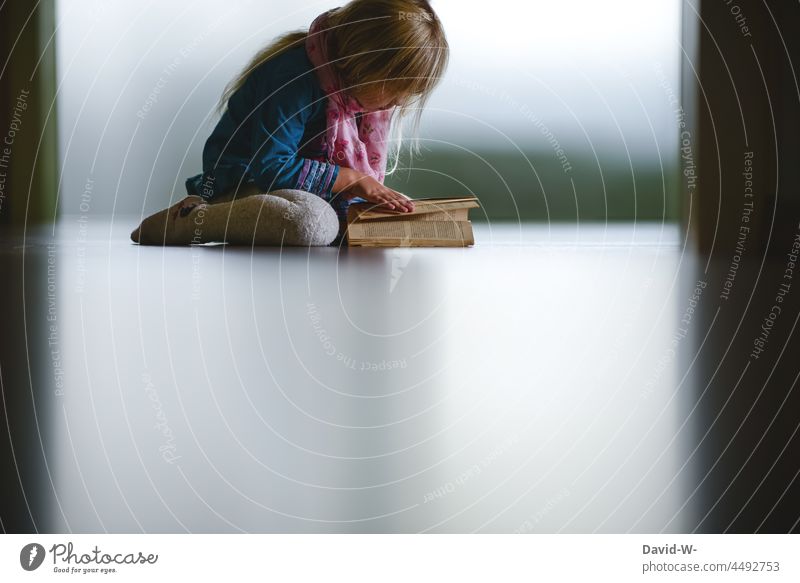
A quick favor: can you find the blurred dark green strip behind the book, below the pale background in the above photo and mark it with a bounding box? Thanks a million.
[386,150,679,222]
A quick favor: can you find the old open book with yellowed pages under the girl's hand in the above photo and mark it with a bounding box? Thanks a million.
[347,196,480,247]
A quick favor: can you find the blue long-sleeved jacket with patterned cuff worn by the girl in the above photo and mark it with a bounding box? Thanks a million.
[186,46,362,213]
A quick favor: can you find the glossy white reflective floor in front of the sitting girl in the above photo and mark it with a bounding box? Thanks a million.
[18,217,690,532]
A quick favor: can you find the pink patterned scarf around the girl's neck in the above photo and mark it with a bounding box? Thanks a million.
[306,11,394,183]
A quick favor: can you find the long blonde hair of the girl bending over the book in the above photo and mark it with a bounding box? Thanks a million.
[218,0,449,174]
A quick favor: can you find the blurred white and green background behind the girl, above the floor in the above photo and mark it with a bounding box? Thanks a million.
[54,0,680,221]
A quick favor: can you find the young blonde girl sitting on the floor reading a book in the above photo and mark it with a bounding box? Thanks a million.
[131,0,448,245]
